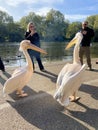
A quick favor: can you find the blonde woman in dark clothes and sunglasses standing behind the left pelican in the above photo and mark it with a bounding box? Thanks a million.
[25,22,44,71]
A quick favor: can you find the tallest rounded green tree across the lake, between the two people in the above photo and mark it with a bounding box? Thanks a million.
[45,9,67,41]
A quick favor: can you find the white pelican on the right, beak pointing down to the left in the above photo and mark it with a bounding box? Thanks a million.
[54,32,86,106]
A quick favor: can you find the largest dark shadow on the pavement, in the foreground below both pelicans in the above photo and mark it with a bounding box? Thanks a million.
[8,90,89,130]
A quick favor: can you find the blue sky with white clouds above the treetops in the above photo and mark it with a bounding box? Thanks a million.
[0,0,98,22]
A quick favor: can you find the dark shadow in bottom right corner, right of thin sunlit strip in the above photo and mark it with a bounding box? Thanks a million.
[69,102,98,130]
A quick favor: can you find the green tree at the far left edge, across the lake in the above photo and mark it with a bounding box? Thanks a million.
[0,11,24,42]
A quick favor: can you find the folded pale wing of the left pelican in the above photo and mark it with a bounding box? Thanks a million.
[3,70,33,94]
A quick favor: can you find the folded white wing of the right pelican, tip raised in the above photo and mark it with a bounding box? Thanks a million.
[54,64,86,105]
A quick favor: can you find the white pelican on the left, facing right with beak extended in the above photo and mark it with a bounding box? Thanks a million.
[3,40,46,97]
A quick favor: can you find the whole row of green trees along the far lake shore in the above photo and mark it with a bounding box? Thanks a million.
[0,9,98,42]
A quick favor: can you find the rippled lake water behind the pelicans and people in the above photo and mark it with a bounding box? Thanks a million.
[0,42,98,66]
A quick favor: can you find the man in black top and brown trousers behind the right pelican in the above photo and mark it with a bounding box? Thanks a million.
[79,21,94,70]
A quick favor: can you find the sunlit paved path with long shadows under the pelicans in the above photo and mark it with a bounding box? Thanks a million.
[0,59,98,130]
